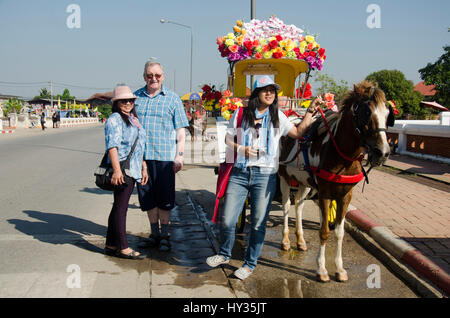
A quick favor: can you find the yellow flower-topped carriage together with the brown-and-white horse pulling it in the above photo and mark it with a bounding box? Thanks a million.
[217,17,394,282]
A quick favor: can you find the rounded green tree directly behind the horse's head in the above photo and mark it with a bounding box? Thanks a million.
[366,70,427,119]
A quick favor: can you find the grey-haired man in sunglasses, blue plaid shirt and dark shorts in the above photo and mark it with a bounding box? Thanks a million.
[134,62,189,251]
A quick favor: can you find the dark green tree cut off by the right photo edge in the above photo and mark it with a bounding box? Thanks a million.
[419,46,450,107]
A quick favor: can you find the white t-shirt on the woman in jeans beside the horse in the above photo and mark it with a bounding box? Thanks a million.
[227,110,294,174]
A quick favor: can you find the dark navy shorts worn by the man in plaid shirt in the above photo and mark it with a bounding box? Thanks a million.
[137,160,175,211]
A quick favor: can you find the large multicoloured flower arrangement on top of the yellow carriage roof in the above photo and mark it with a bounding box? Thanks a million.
[217,16,326,70]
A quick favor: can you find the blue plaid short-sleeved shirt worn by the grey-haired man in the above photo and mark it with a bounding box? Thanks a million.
[134,85,189,161]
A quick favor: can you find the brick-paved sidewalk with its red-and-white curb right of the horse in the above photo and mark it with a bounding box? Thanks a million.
[348,155,450,296]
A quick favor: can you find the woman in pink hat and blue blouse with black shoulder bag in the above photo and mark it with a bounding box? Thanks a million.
[105,86,148,259]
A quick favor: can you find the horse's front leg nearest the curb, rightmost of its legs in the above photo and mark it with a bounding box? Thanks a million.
[334,193,352,282]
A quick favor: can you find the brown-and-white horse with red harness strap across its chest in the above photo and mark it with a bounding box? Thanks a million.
[278,81,395,282]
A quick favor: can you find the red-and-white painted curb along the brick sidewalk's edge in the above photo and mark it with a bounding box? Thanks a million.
[346,207,450,296]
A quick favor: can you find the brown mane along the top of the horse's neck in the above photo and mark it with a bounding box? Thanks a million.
[340,80,386,112]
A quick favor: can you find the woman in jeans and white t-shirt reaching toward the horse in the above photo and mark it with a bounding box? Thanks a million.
[206,75,323,280]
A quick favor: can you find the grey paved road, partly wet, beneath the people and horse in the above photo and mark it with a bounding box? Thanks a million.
[0,125,417,298]
